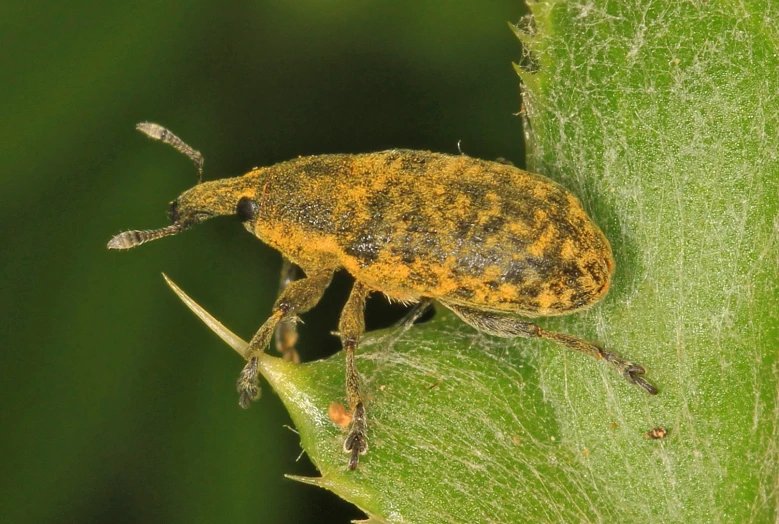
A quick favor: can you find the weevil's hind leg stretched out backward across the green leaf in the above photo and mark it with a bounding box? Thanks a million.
[443,303,657,395]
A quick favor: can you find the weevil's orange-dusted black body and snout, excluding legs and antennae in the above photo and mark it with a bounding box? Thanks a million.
[178,150,614,316]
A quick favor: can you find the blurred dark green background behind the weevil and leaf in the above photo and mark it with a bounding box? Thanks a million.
[0,0,524,523]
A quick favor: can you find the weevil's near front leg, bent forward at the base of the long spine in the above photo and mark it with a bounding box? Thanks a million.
[236,269,333,408]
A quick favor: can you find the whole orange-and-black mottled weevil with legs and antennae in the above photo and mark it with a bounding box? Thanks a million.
[108,123,657,469]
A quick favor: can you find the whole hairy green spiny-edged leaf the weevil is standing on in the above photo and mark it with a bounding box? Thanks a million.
[168,0,779,522]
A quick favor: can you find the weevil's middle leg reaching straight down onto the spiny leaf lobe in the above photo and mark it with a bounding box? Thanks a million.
[338,282,370,469]
